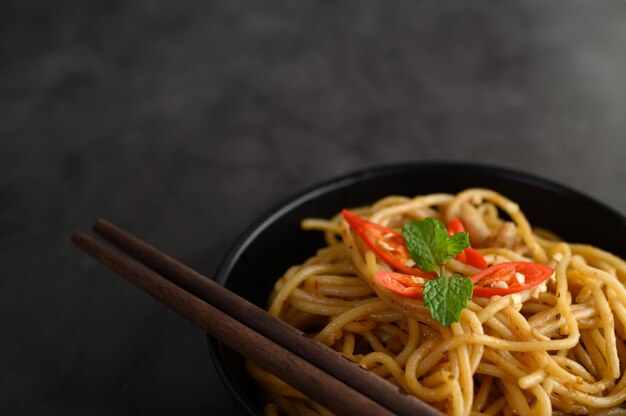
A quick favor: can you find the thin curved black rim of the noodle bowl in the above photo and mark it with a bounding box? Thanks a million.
[207,161,626,415]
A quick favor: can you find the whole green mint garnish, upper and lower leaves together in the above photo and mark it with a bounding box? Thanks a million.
[402,217,474,326]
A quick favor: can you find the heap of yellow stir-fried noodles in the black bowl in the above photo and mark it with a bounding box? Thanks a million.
[247,189,626,416]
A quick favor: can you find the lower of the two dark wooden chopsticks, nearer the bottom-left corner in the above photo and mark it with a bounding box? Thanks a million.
[72,232,393,416]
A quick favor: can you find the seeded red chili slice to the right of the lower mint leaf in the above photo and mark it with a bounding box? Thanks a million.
[472,261,554,298]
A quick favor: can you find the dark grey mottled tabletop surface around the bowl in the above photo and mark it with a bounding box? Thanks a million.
[0,0,626,415]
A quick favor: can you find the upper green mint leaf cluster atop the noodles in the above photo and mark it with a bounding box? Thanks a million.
[402,217,470,272]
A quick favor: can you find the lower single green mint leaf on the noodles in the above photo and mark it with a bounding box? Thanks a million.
[423,274,474,326]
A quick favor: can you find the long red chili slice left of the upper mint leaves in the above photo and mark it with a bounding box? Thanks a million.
[341,209,437,279]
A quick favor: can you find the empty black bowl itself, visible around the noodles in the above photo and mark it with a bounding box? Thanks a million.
[209,163,626,415]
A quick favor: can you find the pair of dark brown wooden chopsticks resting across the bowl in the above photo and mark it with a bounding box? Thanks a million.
[72,220,441,416]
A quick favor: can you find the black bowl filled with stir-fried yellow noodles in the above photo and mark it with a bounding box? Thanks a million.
[209,163,626,415]
